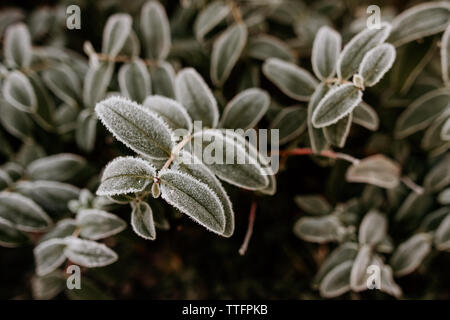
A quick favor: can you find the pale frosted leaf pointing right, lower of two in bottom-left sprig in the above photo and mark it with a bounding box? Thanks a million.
[64,237,118,268]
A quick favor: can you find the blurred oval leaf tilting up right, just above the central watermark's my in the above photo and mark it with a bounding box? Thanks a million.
[220,88,270,130]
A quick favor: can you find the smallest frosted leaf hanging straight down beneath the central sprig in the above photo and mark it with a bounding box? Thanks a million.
[131,202,156,240]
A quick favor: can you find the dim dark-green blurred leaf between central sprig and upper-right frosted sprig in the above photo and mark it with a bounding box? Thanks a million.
[270,106,307,145]
